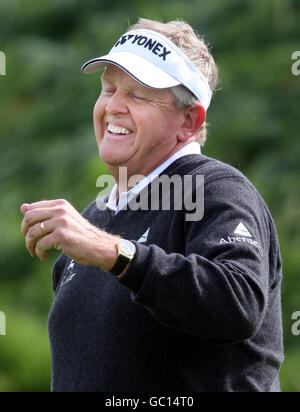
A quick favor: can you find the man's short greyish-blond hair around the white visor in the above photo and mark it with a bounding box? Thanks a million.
[130,18,219,146]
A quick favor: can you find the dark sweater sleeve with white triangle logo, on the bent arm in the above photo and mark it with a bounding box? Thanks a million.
[120,177,276,344]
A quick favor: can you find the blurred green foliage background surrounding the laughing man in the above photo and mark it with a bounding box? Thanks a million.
[0,0,300,392]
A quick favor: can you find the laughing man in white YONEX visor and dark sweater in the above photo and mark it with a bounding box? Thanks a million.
[21,19,283,393]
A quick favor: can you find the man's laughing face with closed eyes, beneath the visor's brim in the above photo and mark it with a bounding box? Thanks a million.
[94,65,184,175]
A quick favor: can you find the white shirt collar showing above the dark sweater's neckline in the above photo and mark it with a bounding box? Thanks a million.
[106,142,201,214]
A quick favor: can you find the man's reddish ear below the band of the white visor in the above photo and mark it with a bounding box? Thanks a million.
[177,104,206,142]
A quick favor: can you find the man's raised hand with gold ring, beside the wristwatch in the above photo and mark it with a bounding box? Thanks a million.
[21,200,120,271]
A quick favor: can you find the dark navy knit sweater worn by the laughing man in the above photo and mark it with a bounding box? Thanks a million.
[48,155,283,393]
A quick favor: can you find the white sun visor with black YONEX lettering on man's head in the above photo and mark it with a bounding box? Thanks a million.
[81,30,212,110]
